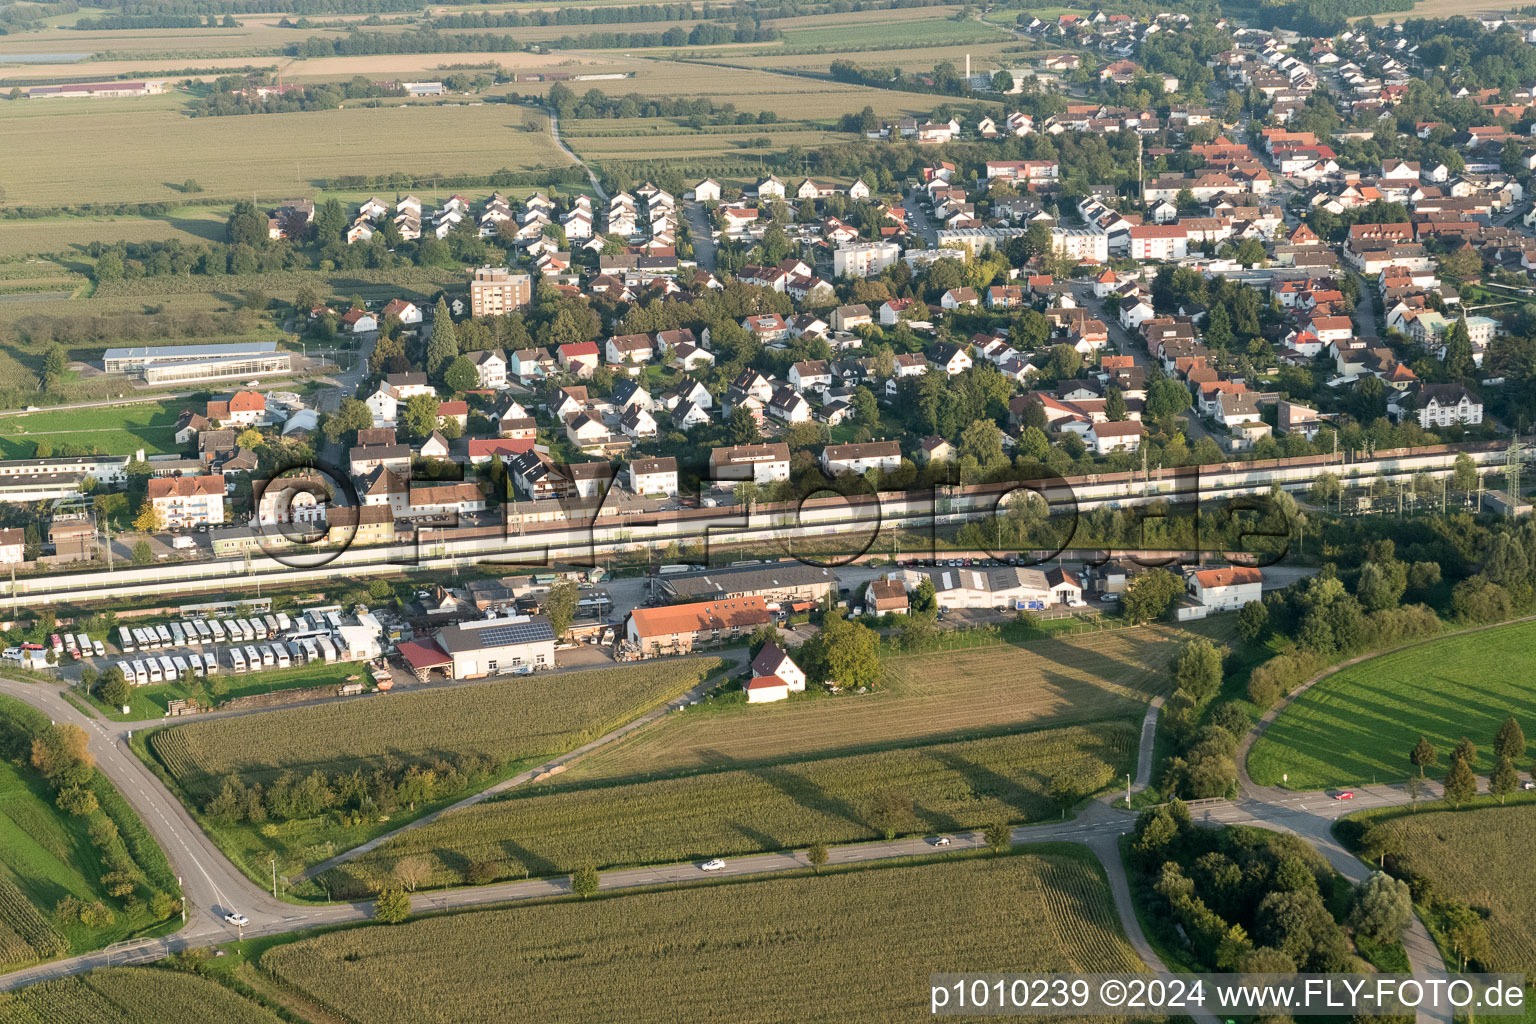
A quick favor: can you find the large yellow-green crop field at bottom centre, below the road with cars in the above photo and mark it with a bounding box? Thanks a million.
[276,846,1143,1024]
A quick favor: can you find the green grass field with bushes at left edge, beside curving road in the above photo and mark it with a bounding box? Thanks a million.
[0,697,177,970]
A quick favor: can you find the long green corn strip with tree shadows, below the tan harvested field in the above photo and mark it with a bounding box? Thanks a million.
[327,722,1140,894]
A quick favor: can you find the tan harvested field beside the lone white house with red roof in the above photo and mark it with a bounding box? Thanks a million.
[567,626,1189,781]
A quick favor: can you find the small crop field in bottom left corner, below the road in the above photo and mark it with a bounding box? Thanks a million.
[0,967,278,1024]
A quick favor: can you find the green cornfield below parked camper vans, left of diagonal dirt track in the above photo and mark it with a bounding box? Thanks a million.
[151,659,720,800]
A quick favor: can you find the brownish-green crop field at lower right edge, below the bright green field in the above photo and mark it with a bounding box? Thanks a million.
[1385,803,1536,973]
